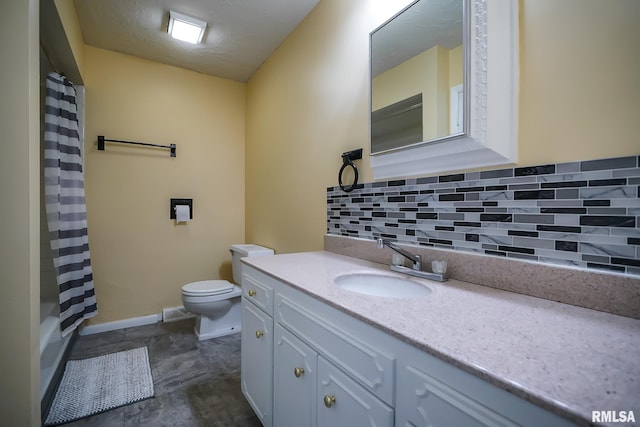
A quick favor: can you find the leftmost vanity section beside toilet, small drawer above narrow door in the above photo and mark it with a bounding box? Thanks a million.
[240,275,273,427]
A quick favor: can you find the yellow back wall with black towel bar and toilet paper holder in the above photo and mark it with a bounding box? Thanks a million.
[84,46,245,323]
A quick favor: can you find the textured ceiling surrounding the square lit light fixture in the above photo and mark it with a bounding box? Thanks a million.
[75,0,319,82]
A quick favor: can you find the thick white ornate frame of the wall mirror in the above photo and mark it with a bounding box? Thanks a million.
[371,0,519,179]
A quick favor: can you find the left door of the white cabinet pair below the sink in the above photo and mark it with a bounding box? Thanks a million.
[273,323,317,427]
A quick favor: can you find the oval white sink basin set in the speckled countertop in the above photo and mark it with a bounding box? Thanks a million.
[335,273,431,298]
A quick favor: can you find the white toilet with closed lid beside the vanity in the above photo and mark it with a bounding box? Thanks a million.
[182,245,273,340]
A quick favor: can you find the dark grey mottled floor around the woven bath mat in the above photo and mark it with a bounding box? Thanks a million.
[46,319,261,427]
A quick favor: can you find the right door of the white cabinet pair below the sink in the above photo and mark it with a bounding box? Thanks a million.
[316,356,394,427]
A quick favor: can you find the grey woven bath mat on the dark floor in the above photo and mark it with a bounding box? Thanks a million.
[45,347,154,425]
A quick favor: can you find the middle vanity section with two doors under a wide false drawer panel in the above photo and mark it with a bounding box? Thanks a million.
[273,289,394,427]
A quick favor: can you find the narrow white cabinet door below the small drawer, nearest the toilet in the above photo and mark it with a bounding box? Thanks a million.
[240,298,273,427]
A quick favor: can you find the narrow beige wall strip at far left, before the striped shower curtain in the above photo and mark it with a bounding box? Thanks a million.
[0,0,40,426]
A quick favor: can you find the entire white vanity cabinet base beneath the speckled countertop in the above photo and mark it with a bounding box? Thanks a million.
[242,266,573,427]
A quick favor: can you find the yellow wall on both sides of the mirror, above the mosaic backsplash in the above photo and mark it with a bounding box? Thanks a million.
[246,0,640,252]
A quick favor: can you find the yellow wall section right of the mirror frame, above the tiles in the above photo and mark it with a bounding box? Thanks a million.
[519,0,640,165]
